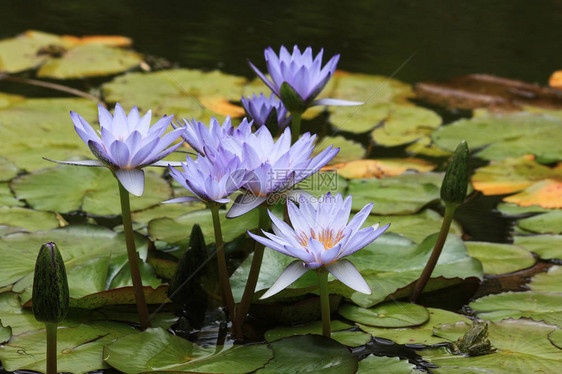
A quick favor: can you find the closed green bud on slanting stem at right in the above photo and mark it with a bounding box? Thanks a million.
[441,140,468,205]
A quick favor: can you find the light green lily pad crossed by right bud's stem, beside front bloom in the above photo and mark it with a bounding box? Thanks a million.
[365,209,462,243]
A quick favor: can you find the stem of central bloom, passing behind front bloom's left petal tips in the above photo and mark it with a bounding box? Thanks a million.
[232,205,271,339]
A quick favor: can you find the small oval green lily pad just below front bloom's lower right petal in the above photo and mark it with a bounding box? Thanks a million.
[338,301,429,327]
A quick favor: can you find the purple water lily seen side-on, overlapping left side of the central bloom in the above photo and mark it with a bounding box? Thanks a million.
[165,147,247,204]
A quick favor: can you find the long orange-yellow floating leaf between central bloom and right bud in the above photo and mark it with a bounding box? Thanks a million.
[332,158,435,179]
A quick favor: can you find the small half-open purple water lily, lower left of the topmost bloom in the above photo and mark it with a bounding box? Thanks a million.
[241,93,291,132]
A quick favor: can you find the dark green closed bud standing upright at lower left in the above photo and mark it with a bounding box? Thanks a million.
[32,243,69,323]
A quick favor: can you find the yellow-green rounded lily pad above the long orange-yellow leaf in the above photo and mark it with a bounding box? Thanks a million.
[371,105,443,147]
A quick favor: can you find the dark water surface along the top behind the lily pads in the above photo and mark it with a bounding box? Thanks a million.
[0,0,562,83]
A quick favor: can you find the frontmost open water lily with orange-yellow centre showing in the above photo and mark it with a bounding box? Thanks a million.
[248,193,390,299]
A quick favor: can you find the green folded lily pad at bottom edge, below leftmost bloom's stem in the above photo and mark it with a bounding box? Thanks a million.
[104,328,273,374]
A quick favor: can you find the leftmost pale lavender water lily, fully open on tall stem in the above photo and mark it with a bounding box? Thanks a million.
[49,103,184,196]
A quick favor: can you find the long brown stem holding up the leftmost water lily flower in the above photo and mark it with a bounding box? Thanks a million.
[117,181,150,330]
